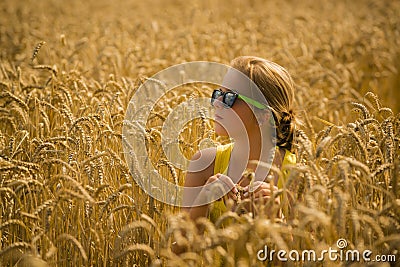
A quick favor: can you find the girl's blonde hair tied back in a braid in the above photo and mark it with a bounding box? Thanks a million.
[231,56,297,151]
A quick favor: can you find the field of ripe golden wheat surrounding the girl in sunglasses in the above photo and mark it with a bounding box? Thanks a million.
[0,0,400,266]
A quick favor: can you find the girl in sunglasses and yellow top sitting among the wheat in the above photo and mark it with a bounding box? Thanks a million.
[183,56,296,222]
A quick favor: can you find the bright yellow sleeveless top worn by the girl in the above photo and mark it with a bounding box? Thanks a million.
[208,143,296,223]
